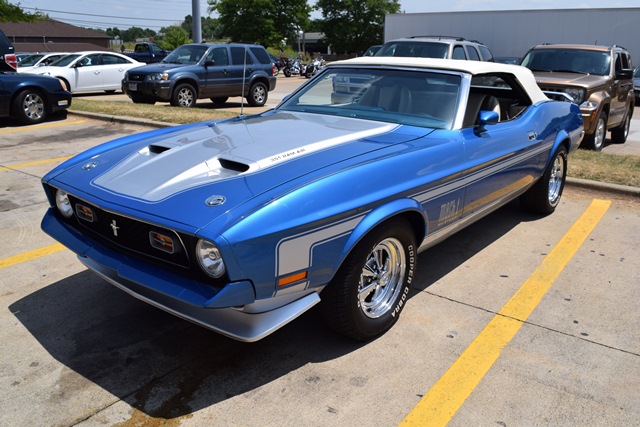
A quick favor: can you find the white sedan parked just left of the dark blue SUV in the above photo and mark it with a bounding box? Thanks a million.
[24,51,144,93]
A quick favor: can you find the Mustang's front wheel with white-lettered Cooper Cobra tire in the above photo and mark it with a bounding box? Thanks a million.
[320,220,417,341]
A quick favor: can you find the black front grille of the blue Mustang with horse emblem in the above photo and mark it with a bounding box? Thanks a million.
[69,195,189,268]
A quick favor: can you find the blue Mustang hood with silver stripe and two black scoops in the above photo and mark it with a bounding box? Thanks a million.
[50,111,432,231]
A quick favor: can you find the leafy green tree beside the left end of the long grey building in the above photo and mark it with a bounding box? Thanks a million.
[315,0,400,53]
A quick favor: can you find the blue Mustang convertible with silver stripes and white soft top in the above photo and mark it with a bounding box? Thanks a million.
[42,57,583,341]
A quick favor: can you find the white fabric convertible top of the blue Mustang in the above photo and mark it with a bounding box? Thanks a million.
[331,56,549,104]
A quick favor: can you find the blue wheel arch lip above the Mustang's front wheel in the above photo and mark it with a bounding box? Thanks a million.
[340,198,428,265]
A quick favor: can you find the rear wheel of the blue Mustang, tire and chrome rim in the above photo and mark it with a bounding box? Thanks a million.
[521,147,567,215]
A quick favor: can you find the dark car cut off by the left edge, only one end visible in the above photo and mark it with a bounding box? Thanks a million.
[0,73,71,125]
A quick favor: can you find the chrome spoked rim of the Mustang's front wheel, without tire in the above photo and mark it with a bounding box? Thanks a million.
[358,238,407,319]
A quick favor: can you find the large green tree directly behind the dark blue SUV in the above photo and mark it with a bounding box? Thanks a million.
[208,0,311,46]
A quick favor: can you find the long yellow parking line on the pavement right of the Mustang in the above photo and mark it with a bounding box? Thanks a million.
[400,200,611,426]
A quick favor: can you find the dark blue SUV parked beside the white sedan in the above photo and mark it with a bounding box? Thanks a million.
[122,43,276,107]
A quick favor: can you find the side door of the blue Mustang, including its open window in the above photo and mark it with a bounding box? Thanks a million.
[462,76,553,217]
